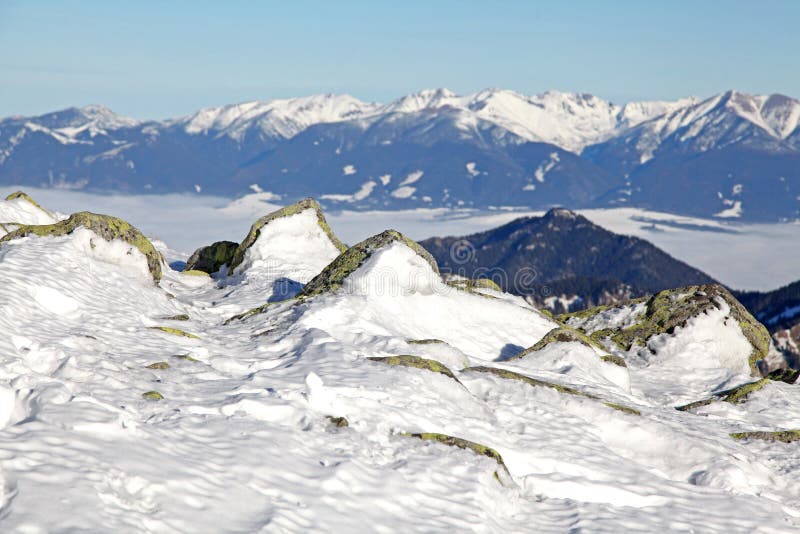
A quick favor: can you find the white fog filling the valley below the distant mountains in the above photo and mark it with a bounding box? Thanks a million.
[0,187,800,291]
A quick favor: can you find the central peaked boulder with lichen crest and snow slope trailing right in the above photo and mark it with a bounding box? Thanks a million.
[292,230,557,361]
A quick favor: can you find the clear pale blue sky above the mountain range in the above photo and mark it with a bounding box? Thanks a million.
[0,0,800,118]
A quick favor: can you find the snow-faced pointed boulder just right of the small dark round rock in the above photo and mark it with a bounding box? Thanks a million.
[228,198,347,283]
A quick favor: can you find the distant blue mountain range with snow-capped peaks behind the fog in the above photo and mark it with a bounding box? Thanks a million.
[0,89,800,220]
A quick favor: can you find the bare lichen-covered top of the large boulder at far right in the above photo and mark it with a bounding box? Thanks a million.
[588,284,770,374]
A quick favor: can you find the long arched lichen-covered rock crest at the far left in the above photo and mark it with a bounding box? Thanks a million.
[0,211,164,283]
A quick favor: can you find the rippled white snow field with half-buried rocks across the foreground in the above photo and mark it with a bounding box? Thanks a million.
[0,195,800,532]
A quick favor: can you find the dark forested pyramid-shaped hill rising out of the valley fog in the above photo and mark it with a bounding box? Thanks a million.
[420,208,714,313]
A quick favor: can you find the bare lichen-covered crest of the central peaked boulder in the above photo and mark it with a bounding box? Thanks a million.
[299,230,439,297]
